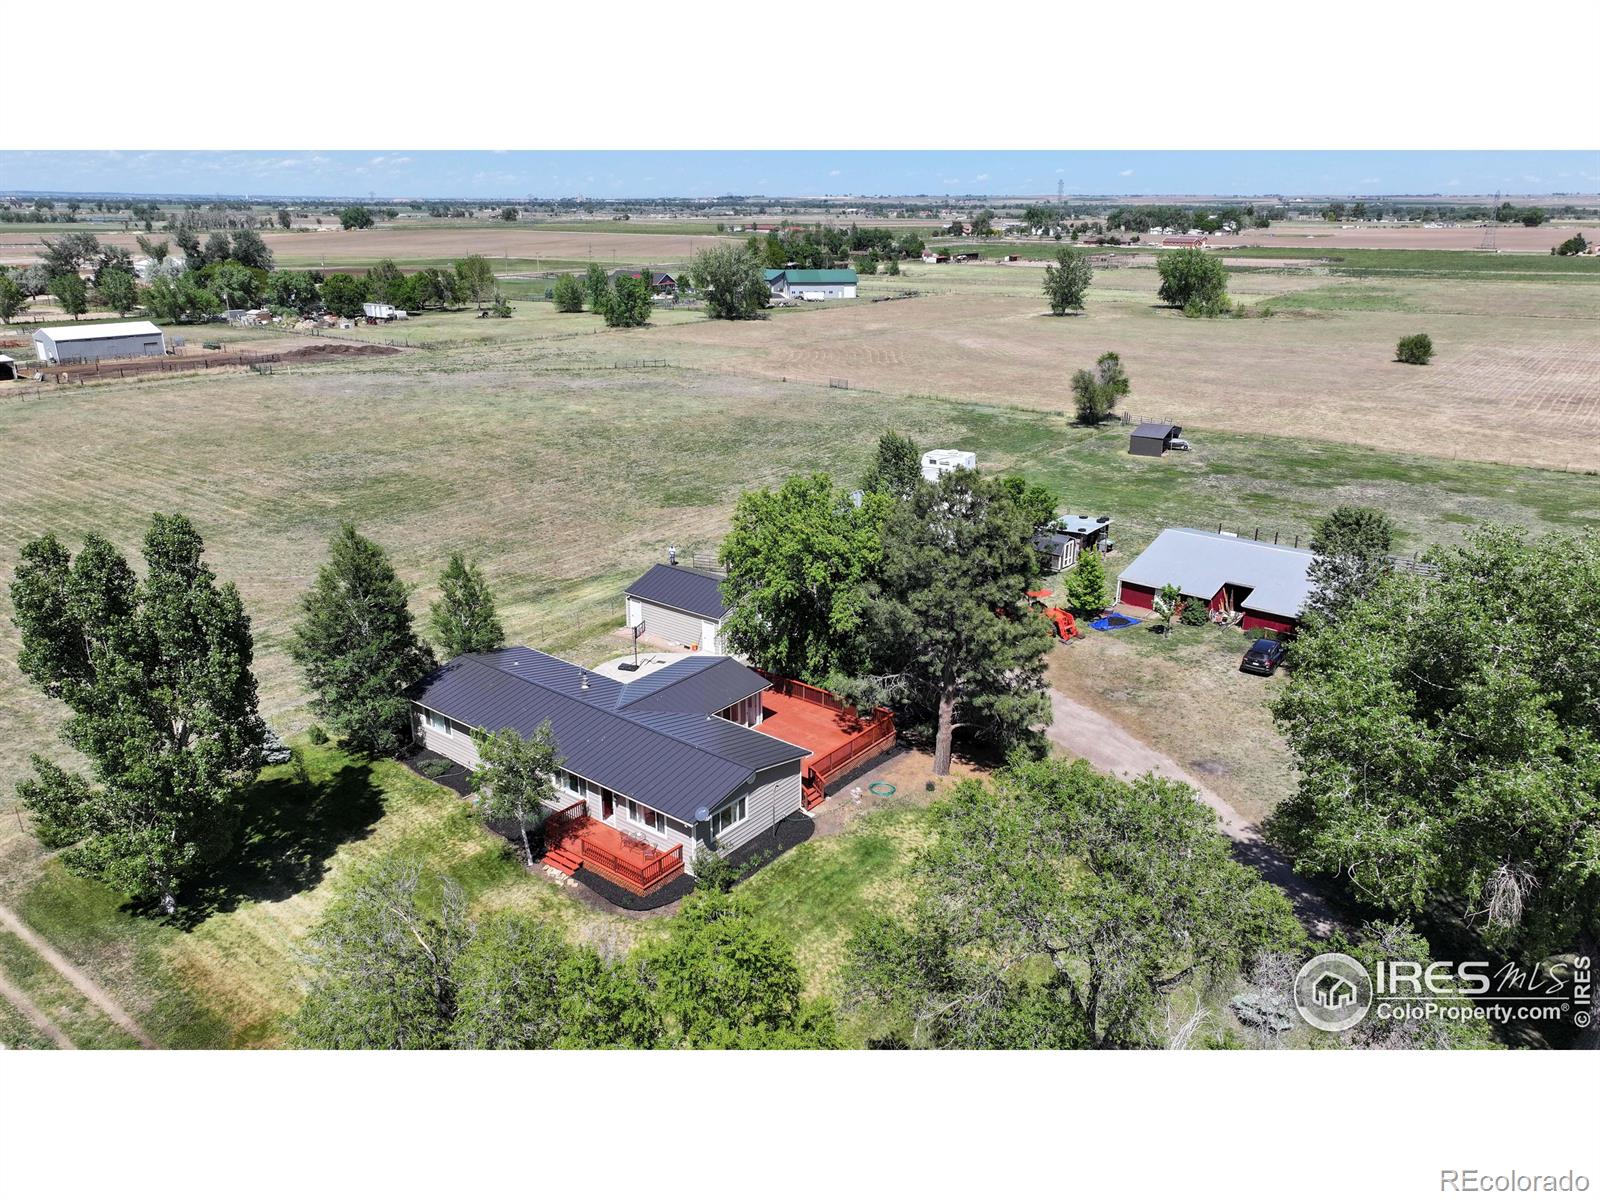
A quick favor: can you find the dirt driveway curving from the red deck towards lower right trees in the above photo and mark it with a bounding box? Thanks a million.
[1048,688,1339,938]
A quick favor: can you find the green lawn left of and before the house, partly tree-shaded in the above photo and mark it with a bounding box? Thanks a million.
[0,744,635,1048]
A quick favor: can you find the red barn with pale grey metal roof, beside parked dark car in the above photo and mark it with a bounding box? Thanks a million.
[1117,530,1314,634]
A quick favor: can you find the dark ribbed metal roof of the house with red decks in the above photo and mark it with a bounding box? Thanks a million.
[411,646,808,822]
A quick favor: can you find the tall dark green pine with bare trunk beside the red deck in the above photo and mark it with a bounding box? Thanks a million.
[872,470,1050,774]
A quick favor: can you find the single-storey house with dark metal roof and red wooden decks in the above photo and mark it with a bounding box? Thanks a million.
[410,646,894,894]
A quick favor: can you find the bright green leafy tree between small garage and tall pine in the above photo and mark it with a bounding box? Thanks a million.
[722,472,894,683]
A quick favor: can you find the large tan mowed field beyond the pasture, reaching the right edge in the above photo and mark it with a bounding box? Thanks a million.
[624,266,1600,470]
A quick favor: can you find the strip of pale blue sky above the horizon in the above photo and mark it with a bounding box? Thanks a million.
[0,150,1600,198]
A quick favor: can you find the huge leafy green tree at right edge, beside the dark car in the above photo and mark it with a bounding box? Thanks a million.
[1274,526,1600,1036]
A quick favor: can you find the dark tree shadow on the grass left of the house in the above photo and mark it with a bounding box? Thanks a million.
[160,763,384,930]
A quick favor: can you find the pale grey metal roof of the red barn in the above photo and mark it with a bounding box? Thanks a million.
[1118,530,1312,618]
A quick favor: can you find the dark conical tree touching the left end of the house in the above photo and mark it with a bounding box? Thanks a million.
[290,522,434,754]
